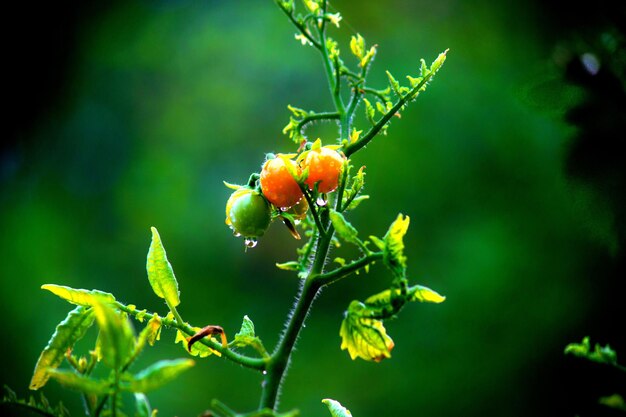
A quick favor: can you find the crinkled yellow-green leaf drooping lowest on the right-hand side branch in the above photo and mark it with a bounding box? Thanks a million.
[339,301,394,362]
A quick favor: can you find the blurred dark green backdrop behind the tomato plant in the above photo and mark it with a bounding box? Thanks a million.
[0,0,626,417]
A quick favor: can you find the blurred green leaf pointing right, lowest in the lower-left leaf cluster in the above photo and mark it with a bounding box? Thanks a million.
[121,359,195,392]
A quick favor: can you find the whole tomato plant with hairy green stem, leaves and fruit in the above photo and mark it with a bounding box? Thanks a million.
[12,0,446,417]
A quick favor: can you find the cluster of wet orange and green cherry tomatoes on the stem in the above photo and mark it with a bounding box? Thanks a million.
[226,141,345,247]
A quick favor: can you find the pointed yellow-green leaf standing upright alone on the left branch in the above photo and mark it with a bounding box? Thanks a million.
[146,227,180,307]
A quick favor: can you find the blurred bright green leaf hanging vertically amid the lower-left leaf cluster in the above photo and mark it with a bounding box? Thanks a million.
[93,303,135,370]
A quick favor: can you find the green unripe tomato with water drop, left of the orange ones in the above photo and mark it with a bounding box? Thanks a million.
[226,188,272,239]
